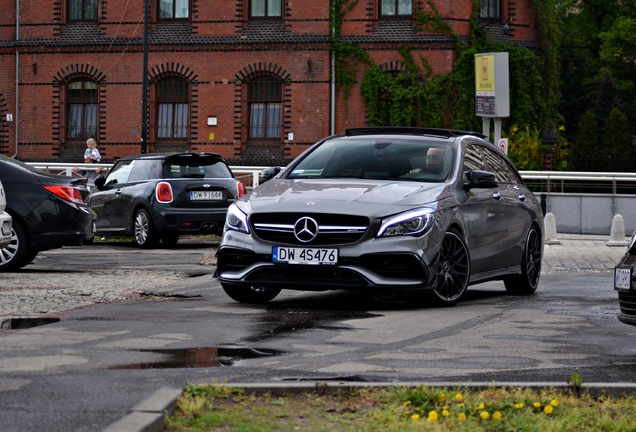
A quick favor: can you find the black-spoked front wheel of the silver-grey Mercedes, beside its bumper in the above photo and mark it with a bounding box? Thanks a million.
[429,230,470,306]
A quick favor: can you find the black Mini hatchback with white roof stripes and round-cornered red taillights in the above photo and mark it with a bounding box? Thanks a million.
[89,153,246,248]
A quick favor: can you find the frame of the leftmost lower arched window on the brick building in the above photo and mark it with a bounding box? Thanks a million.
[65,77,99,141]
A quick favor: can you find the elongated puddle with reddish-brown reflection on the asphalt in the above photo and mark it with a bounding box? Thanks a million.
[109,348,281,370]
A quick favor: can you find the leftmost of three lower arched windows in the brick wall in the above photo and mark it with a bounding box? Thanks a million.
[66,79,98,140]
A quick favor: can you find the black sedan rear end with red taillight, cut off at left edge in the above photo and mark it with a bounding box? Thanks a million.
[0,155,93,271]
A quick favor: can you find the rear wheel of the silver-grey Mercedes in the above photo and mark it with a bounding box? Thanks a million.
[504,226,541,295]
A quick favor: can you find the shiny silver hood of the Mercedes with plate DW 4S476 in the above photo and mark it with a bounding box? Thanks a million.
[239,179,451,216]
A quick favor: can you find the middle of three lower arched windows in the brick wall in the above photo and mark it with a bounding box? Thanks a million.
[156,76,190,139]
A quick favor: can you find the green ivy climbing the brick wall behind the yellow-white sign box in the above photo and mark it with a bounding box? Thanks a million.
[331,0,559,149]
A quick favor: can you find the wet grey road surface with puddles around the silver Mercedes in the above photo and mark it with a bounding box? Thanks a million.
[0,239,636,431]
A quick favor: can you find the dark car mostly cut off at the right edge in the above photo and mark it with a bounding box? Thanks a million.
[614,232,636,326]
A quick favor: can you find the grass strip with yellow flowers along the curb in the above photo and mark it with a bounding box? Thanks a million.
[165,385,636,432]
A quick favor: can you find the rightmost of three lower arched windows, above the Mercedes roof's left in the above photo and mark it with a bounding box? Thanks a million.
[248,76,283,139]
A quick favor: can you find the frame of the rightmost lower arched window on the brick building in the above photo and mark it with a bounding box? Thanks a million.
[247,75,283,141]
